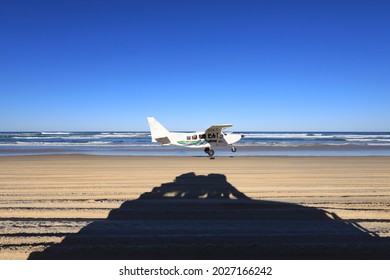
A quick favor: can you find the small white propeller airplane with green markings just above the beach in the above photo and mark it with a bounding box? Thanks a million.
[148,117,244,157]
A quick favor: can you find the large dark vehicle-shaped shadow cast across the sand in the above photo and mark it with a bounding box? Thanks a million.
[29,173,390,259]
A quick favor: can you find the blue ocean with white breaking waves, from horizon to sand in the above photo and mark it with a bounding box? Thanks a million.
[0,131,390,156]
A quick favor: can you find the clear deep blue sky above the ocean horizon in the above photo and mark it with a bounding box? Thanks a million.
[0,0,390,131]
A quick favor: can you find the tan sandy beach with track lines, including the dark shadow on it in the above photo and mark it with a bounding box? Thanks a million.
[0,155,390,259]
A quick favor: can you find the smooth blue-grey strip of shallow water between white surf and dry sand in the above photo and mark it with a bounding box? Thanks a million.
[0,145,390,158]
